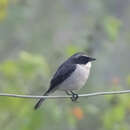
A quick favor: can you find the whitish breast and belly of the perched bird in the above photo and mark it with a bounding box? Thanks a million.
[58,62,91,90]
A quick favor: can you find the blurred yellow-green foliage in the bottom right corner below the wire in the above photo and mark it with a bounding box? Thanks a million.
[103,95,129,130]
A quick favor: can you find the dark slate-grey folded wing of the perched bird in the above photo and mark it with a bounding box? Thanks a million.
[49,64,76,91]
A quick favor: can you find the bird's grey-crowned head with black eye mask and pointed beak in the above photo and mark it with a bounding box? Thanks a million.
[69,52,96,64]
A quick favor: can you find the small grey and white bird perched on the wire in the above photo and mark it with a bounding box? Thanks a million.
[34,52,96,110]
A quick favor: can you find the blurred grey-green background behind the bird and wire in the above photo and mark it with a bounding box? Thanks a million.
[0,0,130,130]
